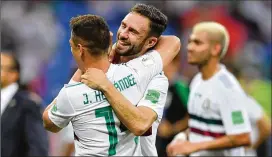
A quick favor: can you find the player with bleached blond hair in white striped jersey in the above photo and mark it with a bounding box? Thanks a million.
[167,22,251,156]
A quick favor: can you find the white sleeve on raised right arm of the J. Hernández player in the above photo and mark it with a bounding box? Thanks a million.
[126,50,163,89]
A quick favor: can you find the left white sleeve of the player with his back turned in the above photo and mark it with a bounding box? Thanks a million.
[48,87,75,128]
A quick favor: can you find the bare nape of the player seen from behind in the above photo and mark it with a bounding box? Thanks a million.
[83,56,110,73]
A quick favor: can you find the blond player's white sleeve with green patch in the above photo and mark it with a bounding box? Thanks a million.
[219,90,251,135]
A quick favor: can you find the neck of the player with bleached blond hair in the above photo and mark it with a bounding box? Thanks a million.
[199,60,220,80]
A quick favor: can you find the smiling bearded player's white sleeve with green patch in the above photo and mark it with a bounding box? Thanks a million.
[138,74,169,121]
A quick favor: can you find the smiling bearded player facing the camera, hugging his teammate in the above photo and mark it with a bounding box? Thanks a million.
[82,4,168,156]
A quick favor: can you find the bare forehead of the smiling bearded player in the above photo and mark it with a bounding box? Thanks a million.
[122,13,150,32]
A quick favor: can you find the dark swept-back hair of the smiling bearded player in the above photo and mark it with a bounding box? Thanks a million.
[130,4,168,37]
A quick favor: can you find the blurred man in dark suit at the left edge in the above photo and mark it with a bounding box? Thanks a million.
[1,52,48,157]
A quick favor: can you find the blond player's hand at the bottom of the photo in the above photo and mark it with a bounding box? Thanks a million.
[166,140,199,156]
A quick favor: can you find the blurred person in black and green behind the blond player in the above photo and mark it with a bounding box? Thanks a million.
[156,55,189,157]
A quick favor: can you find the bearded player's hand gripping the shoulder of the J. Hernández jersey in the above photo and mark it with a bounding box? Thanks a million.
[81,68,110,91]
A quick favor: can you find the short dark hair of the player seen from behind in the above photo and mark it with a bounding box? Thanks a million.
[70,14,110,55]
